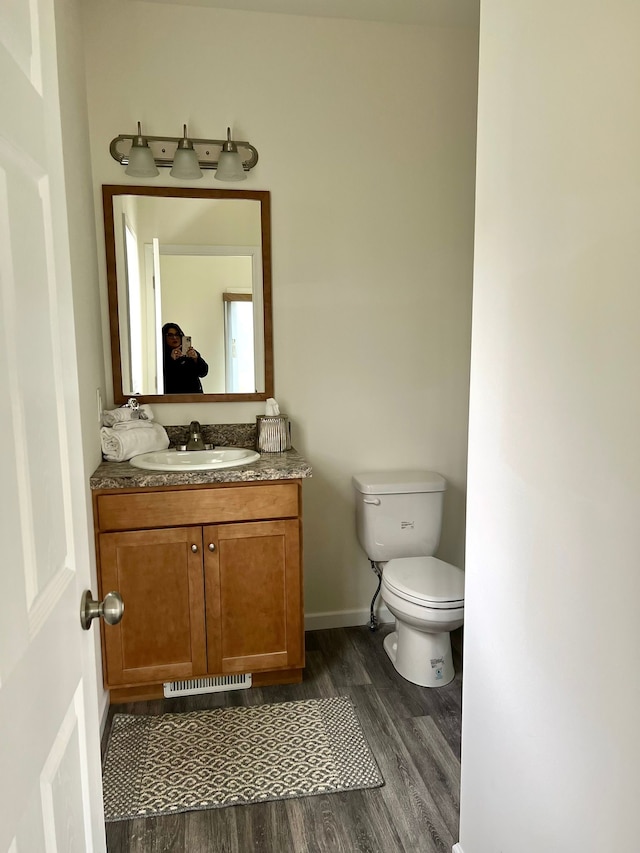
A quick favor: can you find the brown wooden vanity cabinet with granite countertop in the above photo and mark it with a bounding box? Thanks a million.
[91,442,311,702]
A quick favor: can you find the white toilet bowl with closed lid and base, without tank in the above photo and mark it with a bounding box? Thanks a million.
[380,557,464,687]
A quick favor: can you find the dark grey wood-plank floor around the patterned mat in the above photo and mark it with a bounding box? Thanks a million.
[105,625,462,853]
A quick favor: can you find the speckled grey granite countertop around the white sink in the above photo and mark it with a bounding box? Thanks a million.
[89,448,311,489]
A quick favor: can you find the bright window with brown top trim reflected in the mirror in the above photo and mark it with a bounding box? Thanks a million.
[222,293,256,394]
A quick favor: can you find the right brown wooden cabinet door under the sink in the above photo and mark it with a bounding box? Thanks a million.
[203,520,304,674]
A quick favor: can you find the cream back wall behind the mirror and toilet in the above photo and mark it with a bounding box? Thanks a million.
[85,0,477,623]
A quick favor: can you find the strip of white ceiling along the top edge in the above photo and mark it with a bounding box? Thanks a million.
[132,0,480,27]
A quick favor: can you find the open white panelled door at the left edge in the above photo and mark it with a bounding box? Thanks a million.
[0,0,105,853]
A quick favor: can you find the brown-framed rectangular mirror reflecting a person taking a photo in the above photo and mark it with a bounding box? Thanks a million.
[102,186,273,403]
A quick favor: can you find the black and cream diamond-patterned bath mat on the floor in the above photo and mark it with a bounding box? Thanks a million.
[103,696,384,821]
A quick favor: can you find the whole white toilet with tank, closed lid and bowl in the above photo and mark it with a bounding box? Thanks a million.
[353,471,464,687]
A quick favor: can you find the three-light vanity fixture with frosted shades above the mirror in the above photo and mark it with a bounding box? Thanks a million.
[109,122,258,181]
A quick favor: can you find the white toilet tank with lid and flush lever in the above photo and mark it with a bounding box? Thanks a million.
[352,471,447,562]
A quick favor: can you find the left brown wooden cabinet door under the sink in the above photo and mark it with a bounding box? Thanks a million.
[99,527,207,687]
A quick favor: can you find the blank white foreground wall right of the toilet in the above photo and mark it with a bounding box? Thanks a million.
[460,0,640,853]
